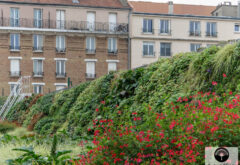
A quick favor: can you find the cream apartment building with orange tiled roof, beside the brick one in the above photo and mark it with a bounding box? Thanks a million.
[129,1,240,68]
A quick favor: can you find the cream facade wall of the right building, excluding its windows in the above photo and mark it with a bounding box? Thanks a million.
[130,14,240,68]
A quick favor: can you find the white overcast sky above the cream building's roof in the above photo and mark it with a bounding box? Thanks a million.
[131,0,238,6]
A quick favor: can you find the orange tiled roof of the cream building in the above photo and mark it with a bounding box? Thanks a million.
[129,1,216,16]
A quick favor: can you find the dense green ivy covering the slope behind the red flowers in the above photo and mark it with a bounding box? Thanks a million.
[7,44,240,137]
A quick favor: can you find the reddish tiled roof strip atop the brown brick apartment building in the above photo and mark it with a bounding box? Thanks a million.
[0,0,130,8]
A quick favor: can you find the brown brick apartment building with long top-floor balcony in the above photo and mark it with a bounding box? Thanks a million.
[0,0,130,96]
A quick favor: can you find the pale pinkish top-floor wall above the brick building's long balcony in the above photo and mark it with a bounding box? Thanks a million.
[0,3,128,23]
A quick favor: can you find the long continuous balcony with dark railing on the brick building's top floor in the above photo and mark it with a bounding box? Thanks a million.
[0,18,128,33]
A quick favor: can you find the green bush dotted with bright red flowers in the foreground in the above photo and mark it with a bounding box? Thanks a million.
[76,92,240,165]
